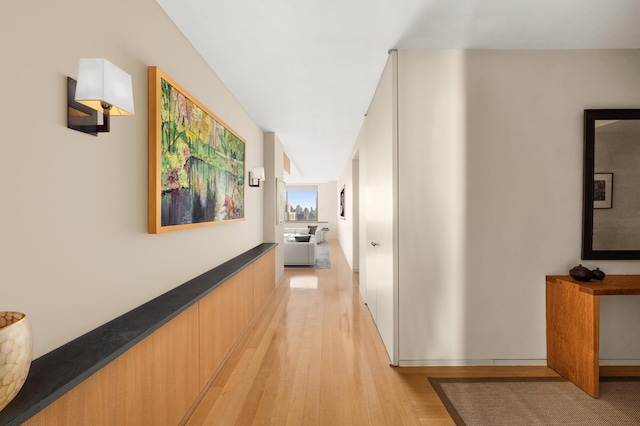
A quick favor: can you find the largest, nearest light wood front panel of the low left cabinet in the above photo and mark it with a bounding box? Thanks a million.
[25,305,200,426]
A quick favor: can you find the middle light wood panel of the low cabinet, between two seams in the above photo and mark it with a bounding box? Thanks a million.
[198,263,255,389]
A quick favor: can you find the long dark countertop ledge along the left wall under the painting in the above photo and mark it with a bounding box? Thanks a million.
[0,243,277,425]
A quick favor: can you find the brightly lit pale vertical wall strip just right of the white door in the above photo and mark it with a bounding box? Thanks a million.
[398,50,467,365]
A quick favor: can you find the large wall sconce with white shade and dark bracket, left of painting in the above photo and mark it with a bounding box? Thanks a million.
[67,58,134,136]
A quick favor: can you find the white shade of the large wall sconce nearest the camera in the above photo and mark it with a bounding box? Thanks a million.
[76,58,134,115]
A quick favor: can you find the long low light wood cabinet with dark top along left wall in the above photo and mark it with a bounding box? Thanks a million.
[0,243,276,426]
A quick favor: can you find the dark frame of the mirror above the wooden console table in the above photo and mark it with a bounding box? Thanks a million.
[582,109,640,260]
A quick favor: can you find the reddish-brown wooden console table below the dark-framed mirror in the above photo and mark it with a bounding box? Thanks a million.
[547,275,640,398]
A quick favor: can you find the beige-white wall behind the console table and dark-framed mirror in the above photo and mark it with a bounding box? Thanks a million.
[399,50,640,365]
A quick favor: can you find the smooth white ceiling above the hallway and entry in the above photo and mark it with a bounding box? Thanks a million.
[157,0,640,182]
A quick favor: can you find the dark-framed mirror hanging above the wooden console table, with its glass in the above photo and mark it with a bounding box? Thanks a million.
[582,109,640,260]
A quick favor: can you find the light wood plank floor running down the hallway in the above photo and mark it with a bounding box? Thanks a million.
[186,240,632,426]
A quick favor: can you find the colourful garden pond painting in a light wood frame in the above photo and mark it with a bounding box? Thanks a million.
[148,66,246,234]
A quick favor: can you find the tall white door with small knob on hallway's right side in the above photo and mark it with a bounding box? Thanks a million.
[361,52,398,365]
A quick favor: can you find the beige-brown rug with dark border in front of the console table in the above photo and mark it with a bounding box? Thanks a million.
[429,377,640,426]
